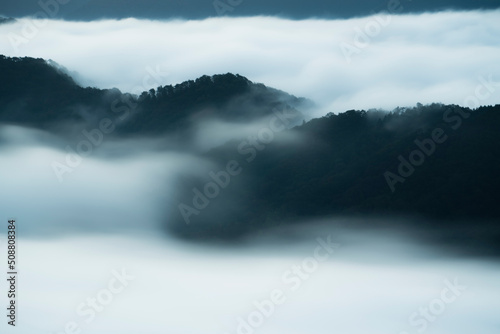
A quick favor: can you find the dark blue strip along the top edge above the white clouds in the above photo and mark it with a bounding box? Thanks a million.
[0,0,500,20]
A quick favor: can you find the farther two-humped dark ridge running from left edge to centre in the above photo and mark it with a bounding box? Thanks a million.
[0,56,310,136]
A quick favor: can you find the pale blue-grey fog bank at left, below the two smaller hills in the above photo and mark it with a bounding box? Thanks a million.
[0,126,213,237]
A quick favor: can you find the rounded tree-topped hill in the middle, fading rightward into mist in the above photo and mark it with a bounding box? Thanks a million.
[124,73,311,133]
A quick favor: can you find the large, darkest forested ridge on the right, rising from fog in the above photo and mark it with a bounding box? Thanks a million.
[171,104,500,238]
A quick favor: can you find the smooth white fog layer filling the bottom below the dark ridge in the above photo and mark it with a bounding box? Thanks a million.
[0,222,500,334]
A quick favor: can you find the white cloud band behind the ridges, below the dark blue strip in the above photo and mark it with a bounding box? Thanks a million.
[0,10,500,113]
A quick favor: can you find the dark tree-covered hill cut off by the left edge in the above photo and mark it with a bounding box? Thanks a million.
[0,56,119,128]
